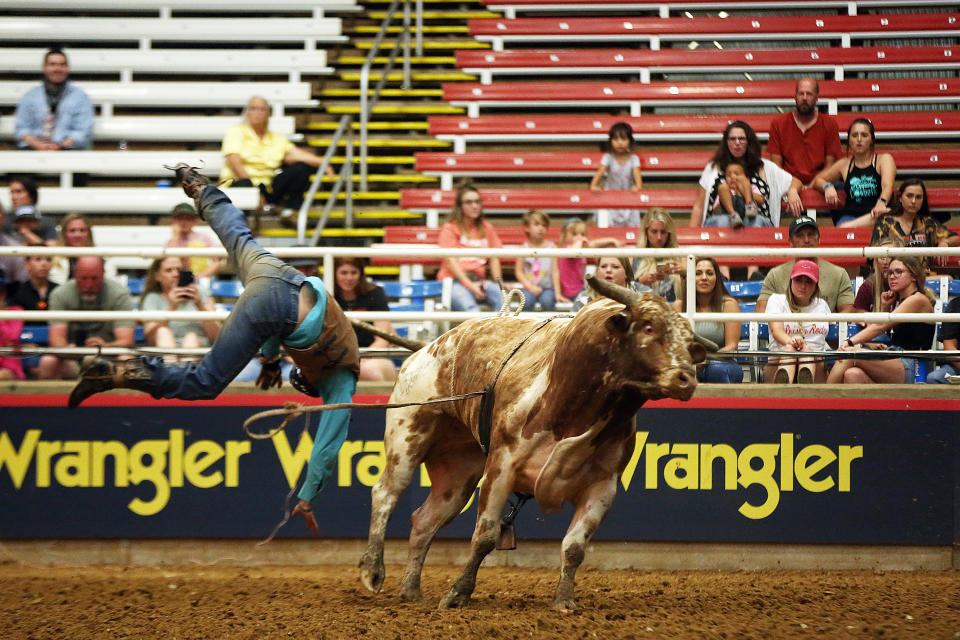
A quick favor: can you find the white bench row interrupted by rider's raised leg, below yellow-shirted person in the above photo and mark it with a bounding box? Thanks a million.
[0,185,260,215]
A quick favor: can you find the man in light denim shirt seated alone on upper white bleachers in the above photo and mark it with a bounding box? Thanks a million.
[14,49,93,151]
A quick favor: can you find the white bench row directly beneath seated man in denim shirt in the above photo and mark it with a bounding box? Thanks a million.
[0,151,224,187]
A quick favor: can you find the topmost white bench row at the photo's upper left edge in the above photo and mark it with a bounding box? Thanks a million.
[0,0,363,18]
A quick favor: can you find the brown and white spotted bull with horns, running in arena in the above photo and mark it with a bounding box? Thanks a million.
[360,280,706,609]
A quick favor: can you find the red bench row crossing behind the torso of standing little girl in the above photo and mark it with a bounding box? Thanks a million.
[418,149,960,189]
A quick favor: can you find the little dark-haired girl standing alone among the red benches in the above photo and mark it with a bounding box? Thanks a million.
[590,122,643,227]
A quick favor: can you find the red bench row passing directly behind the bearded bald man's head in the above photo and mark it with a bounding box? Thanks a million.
[443,78,960,116]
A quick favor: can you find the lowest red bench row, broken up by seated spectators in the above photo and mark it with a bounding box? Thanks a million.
[373,224,960,267]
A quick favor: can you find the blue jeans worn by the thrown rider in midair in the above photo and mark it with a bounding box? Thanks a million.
[145,182,304,400]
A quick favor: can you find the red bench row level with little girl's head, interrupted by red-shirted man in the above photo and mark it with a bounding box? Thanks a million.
[430,111,960,153]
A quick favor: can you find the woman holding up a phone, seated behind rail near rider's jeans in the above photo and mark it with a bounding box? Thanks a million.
[140,258,220,362]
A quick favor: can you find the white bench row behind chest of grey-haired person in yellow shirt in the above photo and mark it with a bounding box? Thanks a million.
[0,115,303,143]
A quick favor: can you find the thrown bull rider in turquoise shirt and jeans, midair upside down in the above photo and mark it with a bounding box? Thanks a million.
[67,165,360,533]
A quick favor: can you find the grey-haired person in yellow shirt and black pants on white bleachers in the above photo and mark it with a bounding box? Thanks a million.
[220,96,334,220]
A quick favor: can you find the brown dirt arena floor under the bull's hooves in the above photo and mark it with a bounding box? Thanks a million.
[0,564,960,640]
